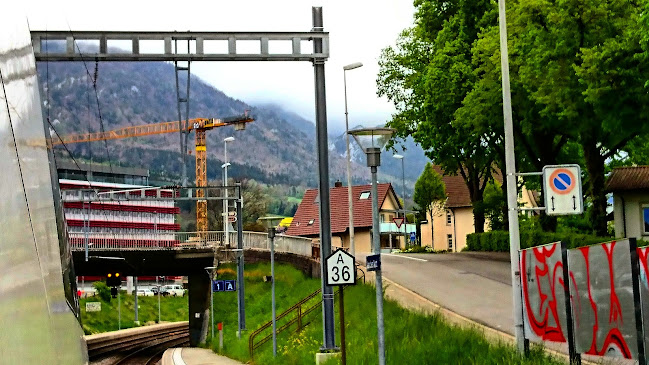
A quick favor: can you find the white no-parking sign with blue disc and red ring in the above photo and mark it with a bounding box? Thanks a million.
[543,165,584,215]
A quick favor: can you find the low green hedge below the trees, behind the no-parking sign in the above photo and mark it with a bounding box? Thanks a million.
[466,231,613,252]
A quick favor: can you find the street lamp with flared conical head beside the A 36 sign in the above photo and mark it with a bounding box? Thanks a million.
[348,128,395,365]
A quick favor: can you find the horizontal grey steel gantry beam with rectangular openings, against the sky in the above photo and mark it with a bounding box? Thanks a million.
[31,29,329,62]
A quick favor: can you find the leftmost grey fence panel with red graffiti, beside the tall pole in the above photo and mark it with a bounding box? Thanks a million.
[521,242,568,342]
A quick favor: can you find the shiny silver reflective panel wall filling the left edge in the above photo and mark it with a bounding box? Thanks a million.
[0,16,87,365]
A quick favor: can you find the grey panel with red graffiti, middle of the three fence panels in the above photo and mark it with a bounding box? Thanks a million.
[568,240,646,358]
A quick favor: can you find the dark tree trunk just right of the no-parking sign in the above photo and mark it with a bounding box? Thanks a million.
[582,140,608,236]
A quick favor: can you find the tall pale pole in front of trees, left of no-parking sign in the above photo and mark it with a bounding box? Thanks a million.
[498,0,525,353]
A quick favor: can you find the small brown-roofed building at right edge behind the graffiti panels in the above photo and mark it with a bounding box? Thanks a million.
[606,166,649,240]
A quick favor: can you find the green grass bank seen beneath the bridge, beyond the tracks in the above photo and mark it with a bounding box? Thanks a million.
[80,291,189,334]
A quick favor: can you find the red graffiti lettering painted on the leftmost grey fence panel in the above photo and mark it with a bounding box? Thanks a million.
[521,243,566,342]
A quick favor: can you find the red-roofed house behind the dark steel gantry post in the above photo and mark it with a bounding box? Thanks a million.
[286,182,415,253]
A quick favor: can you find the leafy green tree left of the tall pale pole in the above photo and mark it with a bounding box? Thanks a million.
[377,0,495,231]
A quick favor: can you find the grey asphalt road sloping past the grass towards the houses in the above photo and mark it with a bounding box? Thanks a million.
[357,252,514,334]
